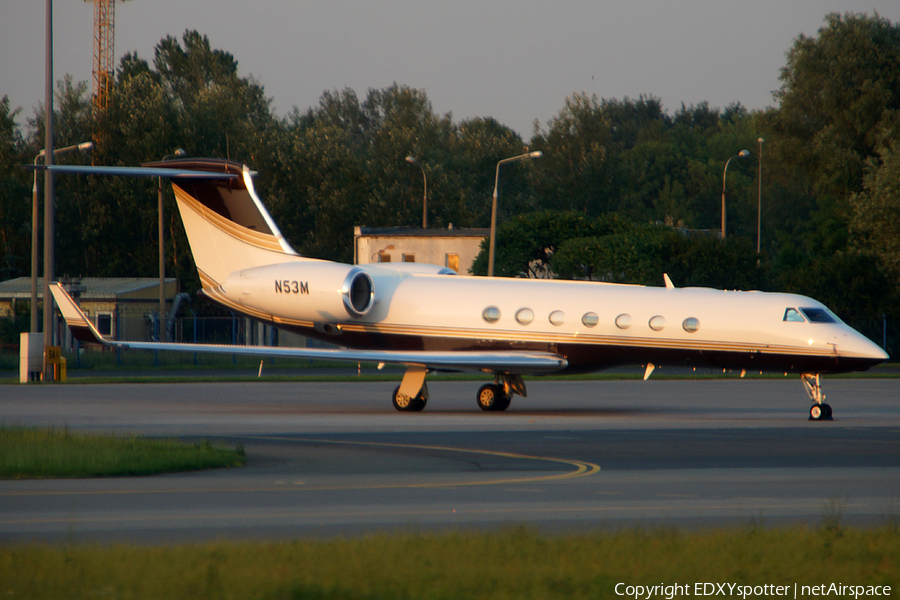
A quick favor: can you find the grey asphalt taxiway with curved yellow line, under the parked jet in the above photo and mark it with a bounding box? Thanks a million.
[0,377,900,543]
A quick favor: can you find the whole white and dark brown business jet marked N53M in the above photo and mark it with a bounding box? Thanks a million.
[42,159,888,420]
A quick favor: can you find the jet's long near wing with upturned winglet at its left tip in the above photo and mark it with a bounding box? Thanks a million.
[50,282,568,374]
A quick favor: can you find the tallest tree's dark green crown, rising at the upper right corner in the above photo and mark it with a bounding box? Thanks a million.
[772,13,900,218]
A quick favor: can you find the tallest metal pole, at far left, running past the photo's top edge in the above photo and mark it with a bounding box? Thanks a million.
[44,0,54,381]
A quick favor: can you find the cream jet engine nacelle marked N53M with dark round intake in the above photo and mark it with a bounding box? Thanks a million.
[222,260,375,323]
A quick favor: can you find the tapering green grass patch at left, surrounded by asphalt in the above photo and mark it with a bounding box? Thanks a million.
[0,426,244,478]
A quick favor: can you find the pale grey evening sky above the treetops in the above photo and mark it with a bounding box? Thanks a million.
[0,0,900,141]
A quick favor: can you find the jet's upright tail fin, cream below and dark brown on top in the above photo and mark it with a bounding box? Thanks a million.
[142,158,299,289]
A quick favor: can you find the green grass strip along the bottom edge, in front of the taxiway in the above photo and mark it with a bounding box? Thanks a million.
[0,525,900,600]
